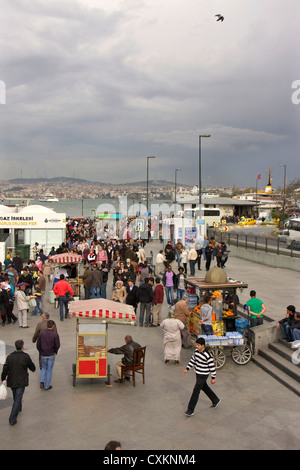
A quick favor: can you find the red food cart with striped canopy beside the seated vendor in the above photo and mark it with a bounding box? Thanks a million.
[69,299,135,387]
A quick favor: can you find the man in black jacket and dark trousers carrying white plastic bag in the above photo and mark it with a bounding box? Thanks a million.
[1,339,35,426]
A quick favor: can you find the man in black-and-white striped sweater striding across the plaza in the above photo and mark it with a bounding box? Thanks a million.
[183,338,221,416]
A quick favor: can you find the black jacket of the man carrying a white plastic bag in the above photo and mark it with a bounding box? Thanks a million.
[1,350,35,388]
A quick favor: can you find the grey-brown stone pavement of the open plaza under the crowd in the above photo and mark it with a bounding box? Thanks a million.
[0,242,300,451]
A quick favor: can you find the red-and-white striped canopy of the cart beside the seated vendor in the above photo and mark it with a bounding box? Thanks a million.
[69,299,135,323]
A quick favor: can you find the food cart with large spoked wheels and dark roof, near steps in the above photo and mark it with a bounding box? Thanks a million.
[186,277,252,369]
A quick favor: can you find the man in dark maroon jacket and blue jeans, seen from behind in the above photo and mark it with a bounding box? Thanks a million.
[36,320,60,390]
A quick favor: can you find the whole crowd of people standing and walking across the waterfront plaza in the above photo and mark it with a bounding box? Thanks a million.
[0,220,300,425]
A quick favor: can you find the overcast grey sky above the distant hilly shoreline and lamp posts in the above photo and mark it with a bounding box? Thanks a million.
[0,0,300,188]
